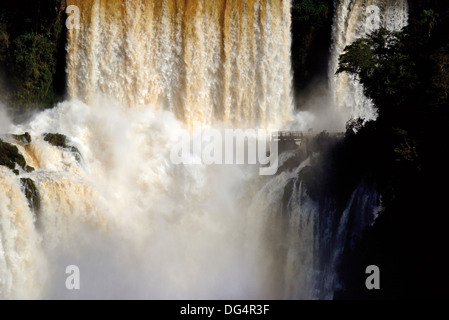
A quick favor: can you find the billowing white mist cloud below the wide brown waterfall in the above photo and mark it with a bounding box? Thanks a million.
[1,99,307,299]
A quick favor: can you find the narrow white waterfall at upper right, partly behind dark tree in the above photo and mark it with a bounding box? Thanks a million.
[329,0,408,120]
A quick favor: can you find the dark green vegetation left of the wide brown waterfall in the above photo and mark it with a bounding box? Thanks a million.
[0,0,65,115]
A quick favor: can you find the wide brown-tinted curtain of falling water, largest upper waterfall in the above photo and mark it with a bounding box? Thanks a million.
[67,0,293,129]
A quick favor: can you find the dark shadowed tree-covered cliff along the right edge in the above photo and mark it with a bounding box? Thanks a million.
[328,1,449,299]
